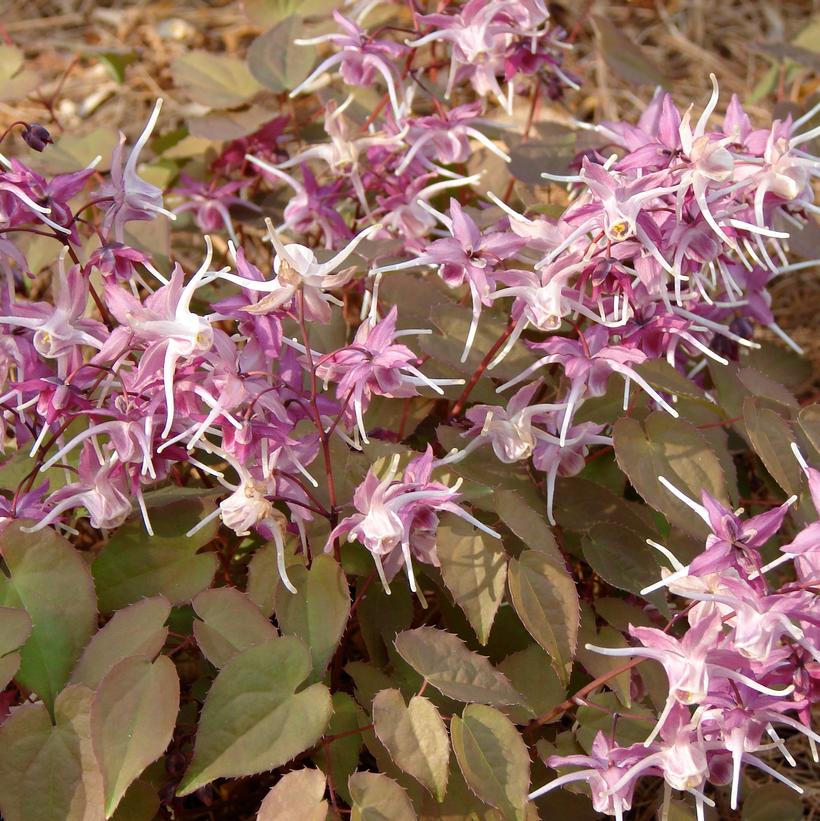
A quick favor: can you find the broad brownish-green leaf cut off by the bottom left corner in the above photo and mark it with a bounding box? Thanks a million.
[0,684,105,821]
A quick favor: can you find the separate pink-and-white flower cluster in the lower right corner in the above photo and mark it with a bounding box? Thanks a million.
[531,462,820,819]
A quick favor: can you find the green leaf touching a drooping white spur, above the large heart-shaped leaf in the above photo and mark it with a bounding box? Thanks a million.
[274,555,350,679]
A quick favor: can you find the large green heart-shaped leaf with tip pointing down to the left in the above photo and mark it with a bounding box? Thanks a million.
[177,636,332,795]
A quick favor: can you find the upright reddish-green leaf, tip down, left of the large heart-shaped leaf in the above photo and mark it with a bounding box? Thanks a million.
[91,656,179,818]
